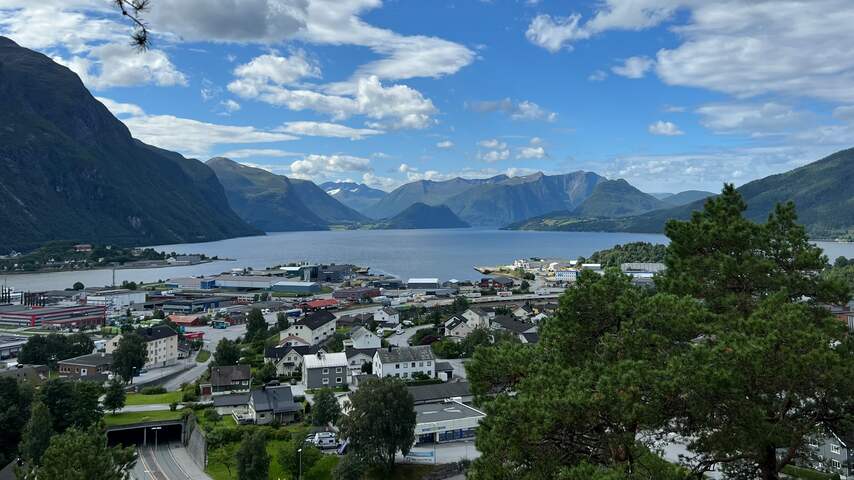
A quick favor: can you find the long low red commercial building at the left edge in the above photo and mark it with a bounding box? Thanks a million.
[0,305,106,328]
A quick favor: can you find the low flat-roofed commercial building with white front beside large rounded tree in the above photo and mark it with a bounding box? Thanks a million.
[415,400,486,444]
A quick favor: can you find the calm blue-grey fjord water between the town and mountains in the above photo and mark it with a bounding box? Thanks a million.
[5,229,854,290]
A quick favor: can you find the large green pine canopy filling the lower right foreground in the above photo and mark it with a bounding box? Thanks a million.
[467,186,854,480]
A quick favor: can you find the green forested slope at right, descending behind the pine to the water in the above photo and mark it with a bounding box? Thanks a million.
[514,149,854,238]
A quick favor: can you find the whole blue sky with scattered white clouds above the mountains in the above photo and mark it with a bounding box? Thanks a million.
[0,0,854,192]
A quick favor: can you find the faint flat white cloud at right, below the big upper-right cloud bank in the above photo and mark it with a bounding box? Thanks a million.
[696,102,811,136]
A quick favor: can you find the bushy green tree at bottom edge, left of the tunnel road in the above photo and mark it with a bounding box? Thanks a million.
[35,427,136,480]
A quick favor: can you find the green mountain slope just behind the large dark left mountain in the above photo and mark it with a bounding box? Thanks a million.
[207,157,328,232]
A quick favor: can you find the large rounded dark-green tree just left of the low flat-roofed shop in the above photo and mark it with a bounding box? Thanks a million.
[341,377,415,472]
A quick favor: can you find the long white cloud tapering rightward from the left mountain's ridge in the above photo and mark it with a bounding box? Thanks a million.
[99,98,297,156]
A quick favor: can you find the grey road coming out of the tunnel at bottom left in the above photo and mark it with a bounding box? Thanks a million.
[131,442,211,480]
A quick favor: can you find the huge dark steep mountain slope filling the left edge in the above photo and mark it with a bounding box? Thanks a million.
[0,37,261,251]
